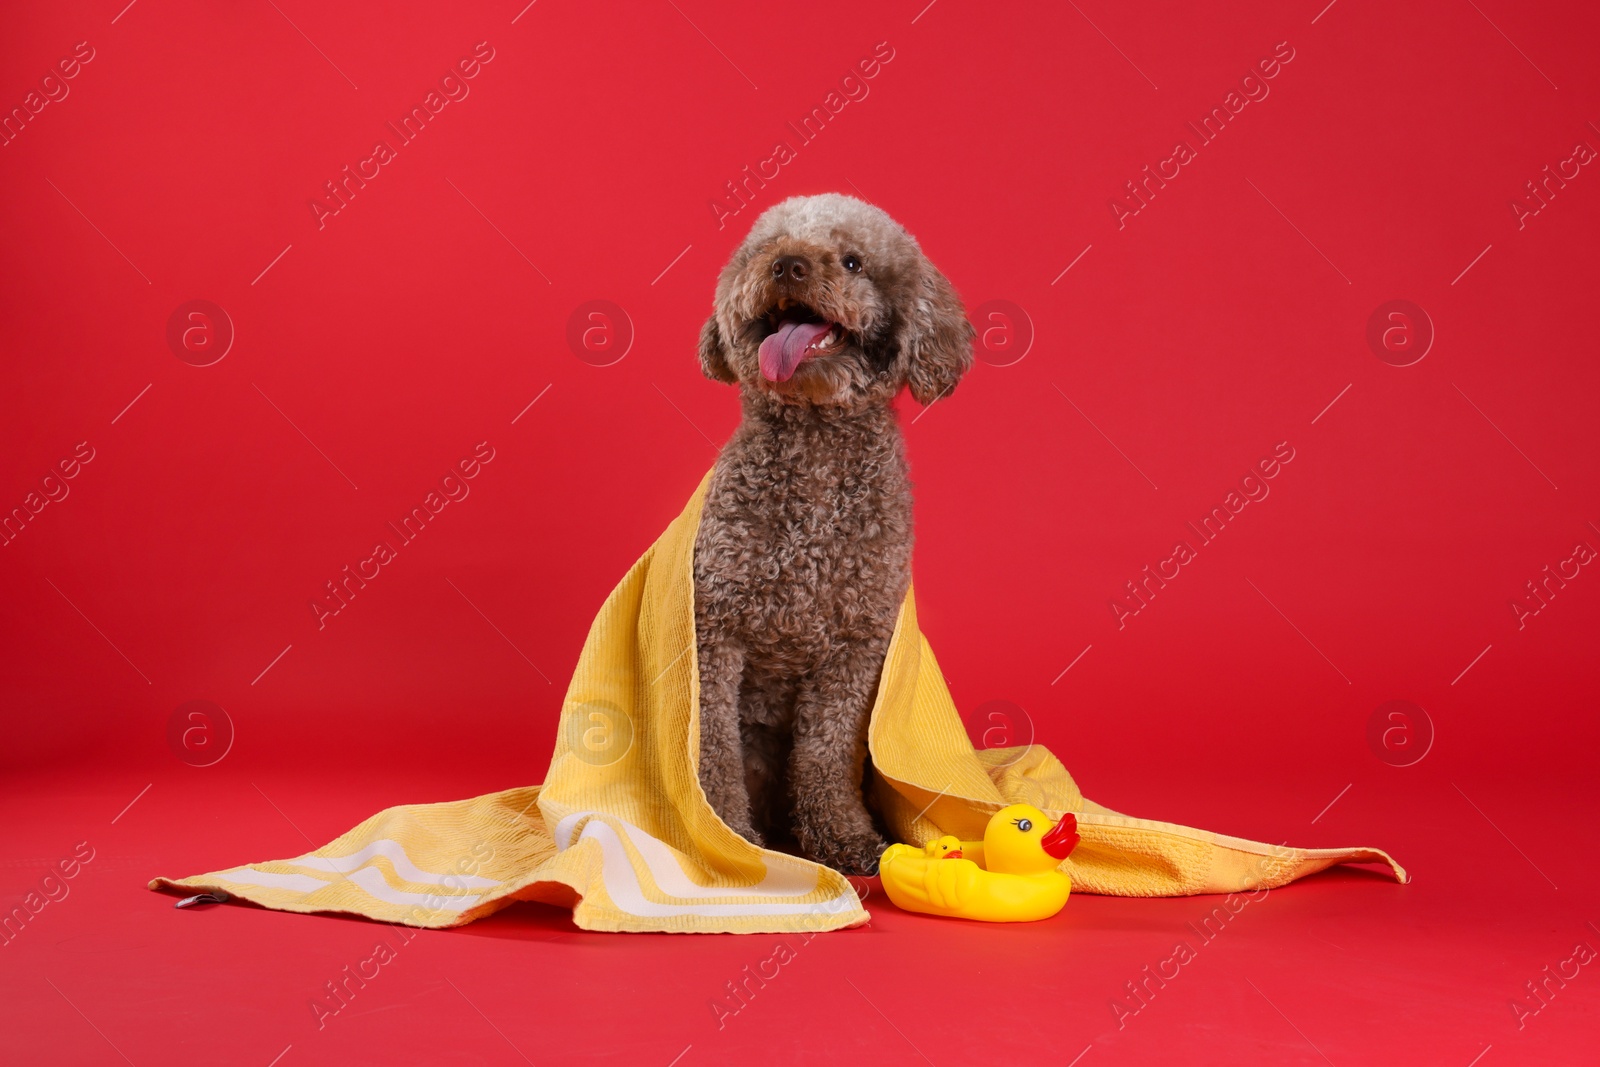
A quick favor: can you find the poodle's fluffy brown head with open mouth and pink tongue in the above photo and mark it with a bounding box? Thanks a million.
[699,194,973,408]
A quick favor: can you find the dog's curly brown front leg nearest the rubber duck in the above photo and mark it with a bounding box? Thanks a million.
[789,641,886,875]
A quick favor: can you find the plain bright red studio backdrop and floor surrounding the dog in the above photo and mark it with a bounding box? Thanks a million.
[0,0,1600,1067]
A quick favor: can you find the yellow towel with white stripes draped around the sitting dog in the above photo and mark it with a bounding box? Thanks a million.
[150,475,1406,933]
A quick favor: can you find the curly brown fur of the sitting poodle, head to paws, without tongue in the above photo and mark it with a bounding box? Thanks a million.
[694,194,973,873]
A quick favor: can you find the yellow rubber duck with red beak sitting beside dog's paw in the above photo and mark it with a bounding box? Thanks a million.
[878,805,1078,923]
